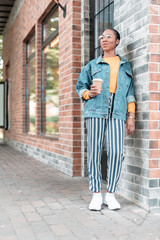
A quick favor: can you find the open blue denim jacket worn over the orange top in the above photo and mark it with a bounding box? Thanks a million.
[76,55,135,121]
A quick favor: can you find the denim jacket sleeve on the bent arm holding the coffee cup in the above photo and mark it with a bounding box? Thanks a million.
[76,63,92,100]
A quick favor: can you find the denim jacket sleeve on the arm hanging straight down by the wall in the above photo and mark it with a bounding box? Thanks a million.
[127,62,136,104]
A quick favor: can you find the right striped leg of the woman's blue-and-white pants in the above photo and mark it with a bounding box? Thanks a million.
[107,117,125,192]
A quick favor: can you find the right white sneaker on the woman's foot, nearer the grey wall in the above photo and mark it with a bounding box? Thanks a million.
[104,192,121,210]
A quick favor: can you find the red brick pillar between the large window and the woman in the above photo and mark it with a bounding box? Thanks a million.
[59,0,81,176]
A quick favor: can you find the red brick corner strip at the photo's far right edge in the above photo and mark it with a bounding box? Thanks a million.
[149,0,160,180]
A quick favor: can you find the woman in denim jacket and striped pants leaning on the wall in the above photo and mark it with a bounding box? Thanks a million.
[76,29,135,210]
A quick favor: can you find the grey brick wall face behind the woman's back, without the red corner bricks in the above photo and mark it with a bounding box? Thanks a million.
[114,0,160,211]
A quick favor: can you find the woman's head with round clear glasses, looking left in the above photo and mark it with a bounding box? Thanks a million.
[99,29,119,52]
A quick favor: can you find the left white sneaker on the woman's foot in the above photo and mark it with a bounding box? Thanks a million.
[89,193,103,211]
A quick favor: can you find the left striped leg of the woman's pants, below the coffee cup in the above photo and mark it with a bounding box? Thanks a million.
[86,118,106,192]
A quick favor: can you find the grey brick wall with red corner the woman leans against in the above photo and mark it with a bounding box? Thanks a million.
[114,0,160,211]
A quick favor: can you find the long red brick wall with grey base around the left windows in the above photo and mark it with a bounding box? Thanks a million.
[3,0,81,176]
